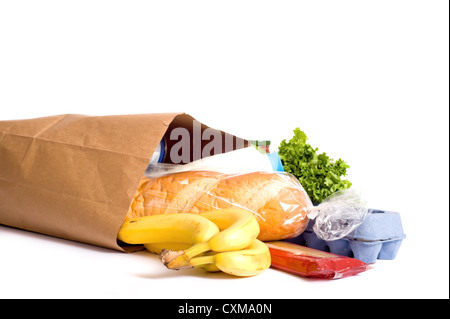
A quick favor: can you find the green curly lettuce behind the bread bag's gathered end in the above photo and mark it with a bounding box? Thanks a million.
[278,128,352,204]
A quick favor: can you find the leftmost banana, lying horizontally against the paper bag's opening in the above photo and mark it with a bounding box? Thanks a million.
[117,213,219,245]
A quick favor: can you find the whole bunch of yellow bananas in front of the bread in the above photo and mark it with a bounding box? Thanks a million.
[118,208,271,276]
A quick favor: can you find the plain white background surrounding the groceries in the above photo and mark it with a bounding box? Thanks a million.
[0,0,449,298]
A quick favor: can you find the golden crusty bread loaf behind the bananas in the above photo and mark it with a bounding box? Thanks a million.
[126,171,312,241]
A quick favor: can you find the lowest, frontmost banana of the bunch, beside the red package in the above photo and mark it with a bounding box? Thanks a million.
[170,239,271,276]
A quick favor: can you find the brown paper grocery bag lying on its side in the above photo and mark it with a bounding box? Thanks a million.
[0,113,247,251]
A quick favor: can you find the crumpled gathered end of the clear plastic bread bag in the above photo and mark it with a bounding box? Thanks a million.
[308,188,369,241]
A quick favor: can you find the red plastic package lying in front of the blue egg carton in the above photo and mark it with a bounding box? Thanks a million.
[266,241,370,279]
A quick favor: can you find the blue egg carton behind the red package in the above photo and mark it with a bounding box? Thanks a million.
[286,209,406,264]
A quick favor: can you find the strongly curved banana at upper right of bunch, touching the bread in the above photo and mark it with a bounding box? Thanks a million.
[161,208,260,269]
